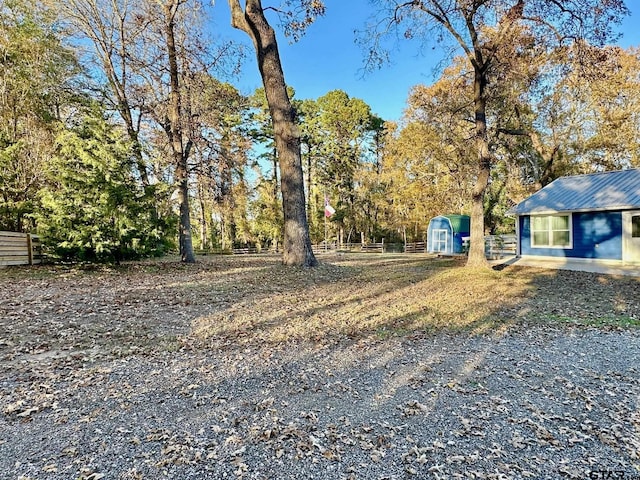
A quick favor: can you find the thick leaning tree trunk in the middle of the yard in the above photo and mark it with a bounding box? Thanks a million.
[228,0,318,267]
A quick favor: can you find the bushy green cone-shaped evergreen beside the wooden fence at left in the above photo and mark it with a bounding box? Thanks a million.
[36,109,173,262]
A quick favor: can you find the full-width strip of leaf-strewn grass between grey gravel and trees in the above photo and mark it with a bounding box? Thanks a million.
[0,254,640,358]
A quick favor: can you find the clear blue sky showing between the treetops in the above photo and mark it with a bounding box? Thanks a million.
[213,0,640,120]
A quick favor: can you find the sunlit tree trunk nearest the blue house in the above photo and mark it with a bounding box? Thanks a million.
[467,66,491,266]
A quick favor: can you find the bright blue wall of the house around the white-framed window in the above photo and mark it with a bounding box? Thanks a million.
[520,212,622,260]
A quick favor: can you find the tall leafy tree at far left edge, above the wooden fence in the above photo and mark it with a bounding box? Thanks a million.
[0,0,82,231]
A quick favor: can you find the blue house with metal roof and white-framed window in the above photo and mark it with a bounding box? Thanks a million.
[507,169,640,264]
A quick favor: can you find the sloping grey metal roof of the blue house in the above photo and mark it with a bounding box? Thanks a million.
[507,169,640,215]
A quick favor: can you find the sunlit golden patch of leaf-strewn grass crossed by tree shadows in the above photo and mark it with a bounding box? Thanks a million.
[188,257,527,343]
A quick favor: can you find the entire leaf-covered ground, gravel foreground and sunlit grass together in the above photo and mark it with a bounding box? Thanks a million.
[0,254,640,480]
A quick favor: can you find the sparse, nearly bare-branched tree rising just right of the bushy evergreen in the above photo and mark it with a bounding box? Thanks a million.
[58,0,235,263]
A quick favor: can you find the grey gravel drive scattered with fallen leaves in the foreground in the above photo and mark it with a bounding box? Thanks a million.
[0,327,640,480]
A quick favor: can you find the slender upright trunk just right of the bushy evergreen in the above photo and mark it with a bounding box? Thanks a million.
[163,0,196,263]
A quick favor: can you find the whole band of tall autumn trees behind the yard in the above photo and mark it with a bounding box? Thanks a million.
[0,0,640,266]
